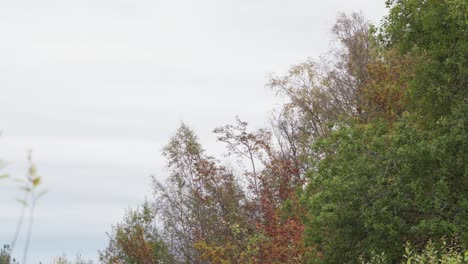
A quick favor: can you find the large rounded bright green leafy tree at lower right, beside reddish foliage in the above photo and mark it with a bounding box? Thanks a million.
[304,108,468,263]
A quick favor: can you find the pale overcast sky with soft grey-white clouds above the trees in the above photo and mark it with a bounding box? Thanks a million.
[0,0,385,263]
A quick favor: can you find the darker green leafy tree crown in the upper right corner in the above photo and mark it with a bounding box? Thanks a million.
[381,0,468,118]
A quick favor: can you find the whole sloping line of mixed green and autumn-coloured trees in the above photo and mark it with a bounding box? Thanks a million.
[1,0,468,264]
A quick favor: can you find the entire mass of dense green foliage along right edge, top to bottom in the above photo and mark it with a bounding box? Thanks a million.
[303,0,468,263]
